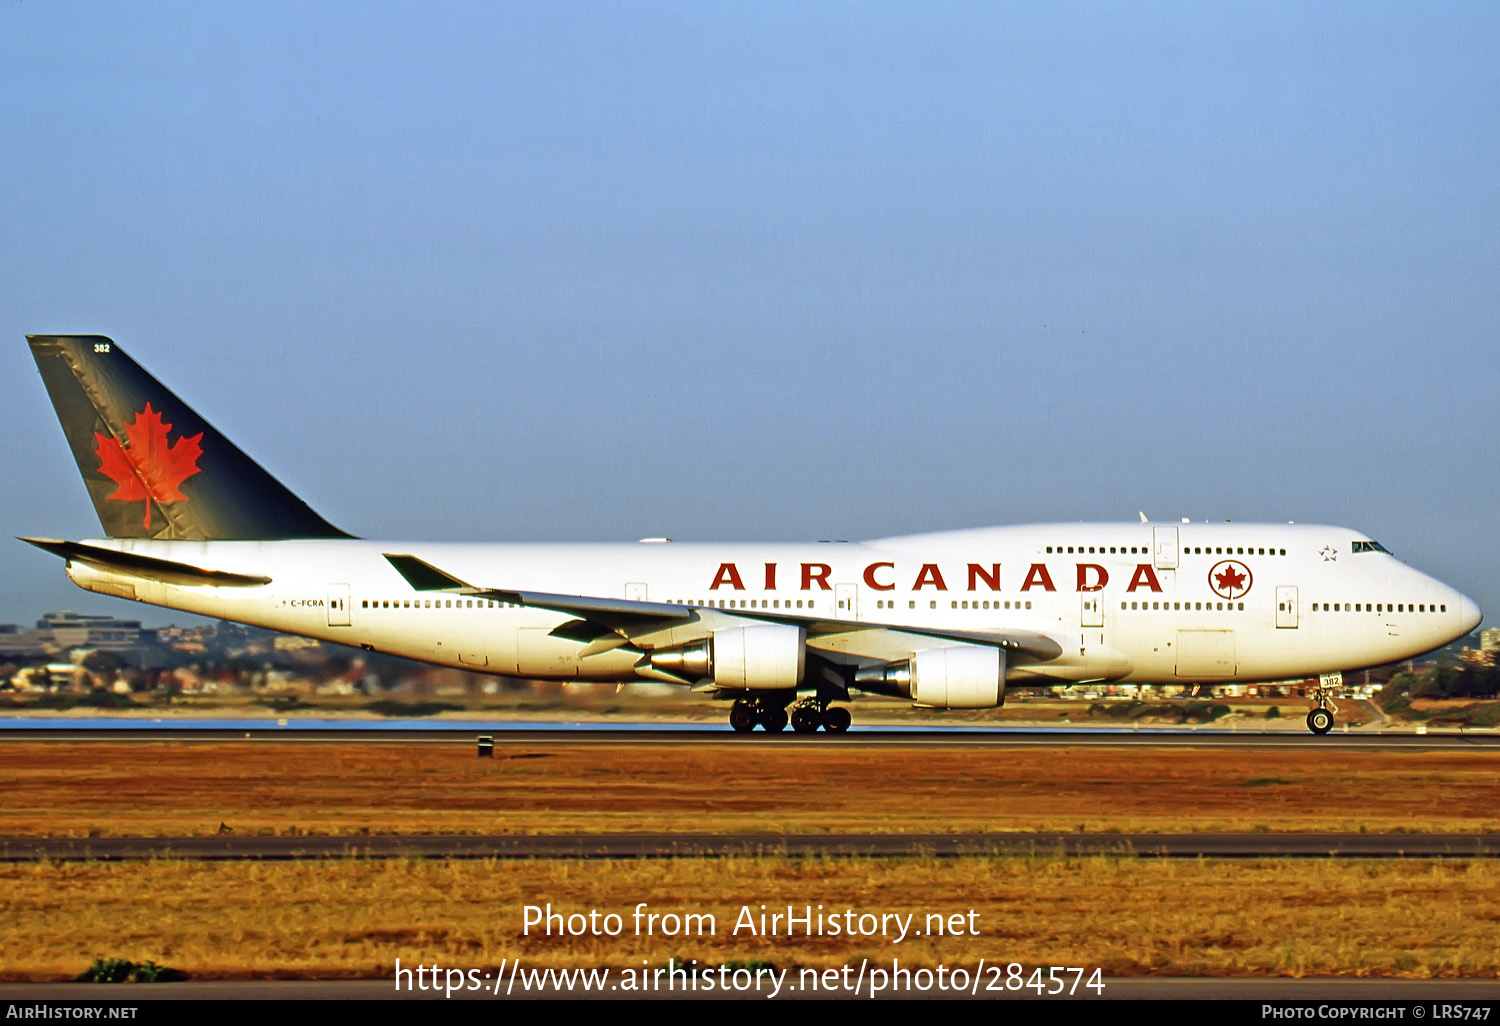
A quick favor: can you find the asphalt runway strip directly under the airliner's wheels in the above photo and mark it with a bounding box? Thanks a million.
[0,723,1500,752]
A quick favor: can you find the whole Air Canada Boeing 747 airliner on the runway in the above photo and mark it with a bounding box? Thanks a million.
[17,335,1481,734]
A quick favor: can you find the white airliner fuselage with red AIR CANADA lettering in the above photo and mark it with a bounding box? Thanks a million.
[58,524,1479,684]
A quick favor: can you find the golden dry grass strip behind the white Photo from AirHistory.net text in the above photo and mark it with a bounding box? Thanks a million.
[0,858,1500,980]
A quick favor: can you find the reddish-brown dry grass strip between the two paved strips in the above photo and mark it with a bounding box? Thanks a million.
[0,740,1500,837]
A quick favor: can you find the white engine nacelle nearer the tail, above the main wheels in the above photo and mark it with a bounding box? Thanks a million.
[647,624,807,692]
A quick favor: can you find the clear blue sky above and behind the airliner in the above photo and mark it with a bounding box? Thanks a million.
[0,0,1500,623]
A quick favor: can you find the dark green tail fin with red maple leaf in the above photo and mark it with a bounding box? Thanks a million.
[27,335,350,540]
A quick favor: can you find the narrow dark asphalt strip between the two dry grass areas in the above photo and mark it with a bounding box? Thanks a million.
[0,833,1500,863]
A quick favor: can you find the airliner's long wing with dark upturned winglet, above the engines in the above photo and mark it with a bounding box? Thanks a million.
[384,552,1062,660]
